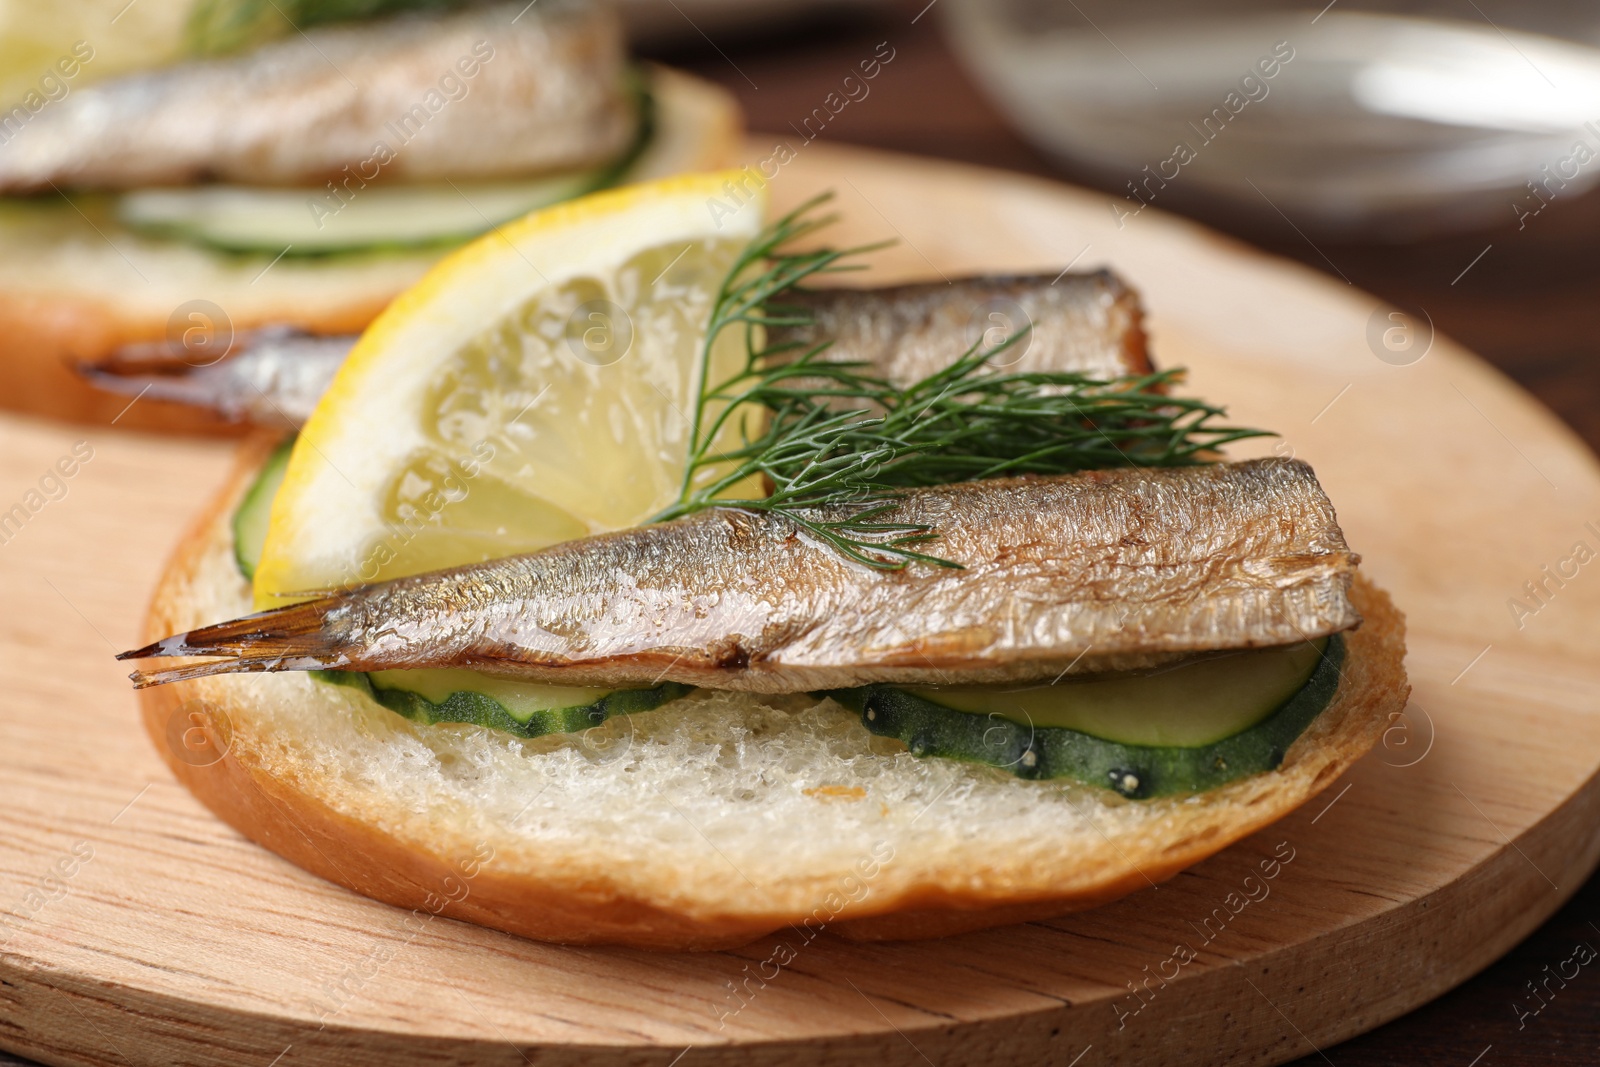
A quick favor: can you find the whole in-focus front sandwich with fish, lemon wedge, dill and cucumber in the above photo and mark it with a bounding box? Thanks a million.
[123,174,1408,950]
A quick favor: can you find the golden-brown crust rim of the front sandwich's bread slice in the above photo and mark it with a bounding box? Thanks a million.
[139,438,1410,950]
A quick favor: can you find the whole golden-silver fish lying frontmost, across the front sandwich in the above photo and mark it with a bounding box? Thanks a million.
[123,459,1360,693]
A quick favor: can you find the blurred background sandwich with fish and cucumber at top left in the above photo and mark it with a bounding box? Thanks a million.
[0,0,741,429]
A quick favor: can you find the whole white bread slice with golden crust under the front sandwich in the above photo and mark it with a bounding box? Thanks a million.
[141,440,1410,949]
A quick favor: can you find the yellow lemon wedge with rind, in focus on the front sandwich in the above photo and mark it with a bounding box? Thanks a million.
[254,173,765,608]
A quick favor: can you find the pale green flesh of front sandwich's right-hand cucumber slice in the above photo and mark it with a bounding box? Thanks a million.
[909,641,1326,749]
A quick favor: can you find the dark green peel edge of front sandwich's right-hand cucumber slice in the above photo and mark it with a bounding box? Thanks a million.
[830,635,1344,800]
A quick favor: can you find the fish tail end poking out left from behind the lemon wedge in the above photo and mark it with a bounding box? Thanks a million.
[78,326,355,429]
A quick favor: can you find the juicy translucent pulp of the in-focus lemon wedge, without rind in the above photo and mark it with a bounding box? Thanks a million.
[358,240,744,581]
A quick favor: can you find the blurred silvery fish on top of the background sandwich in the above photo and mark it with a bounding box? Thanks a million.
[0,3,635,194]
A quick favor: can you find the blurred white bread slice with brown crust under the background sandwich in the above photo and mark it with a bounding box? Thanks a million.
[0,67,742,434]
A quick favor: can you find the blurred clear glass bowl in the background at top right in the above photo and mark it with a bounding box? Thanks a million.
[944,0,1600,240]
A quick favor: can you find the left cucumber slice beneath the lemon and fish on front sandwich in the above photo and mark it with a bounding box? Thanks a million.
[234,437,690,737]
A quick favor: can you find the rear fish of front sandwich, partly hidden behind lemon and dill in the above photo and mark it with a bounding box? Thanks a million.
[83,270,1152,427]
